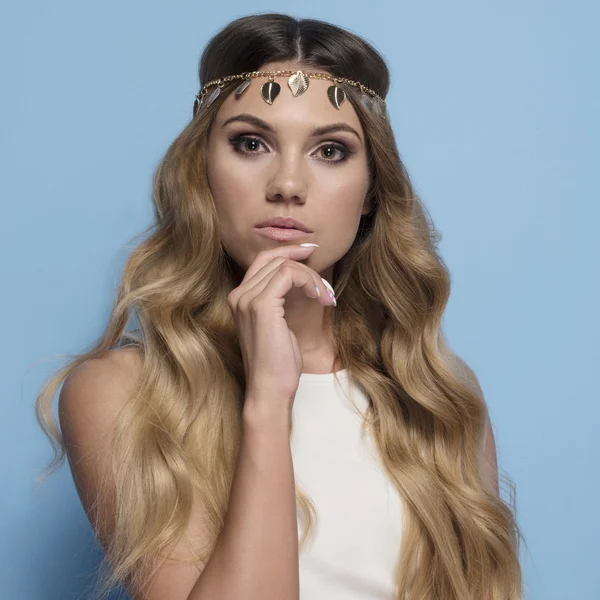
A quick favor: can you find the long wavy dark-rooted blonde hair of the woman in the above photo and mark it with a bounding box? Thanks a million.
[35,13,522,600]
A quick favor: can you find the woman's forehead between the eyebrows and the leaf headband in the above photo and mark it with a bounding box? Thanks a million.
[216,72,362,134]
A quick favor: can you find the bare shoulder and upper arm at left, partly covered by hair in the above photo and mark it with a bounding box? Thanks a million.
[59,346,208,600]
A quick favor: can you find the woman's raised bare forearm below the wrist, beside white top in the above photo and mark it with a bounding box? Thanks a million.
[188,398,299,600]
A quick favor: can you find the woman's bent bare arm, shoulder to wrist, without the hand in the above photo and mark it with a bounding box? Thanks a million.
[59,349,299,600]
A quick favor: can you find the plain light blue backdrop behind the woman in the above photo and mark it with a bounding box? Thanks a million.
[0,0,600,600]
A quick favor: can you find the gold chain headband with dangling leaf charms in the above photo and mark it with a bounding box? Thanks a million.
[193,71,385,117]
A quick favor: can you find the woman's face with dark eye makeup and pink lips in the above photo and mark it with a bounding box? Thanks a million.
[207,63,370,273]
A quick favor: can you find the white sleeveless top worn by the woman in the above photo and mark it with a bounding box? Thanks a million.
[291,369,402,600]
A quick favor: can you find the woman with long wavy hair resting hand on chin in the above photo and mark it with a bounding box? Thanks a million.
[36,14,521,600]
